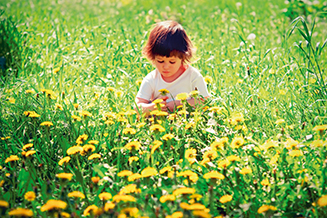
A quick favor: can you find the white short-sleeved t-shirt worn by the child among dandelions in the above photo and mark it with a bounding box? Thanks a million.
[136,66,209,102]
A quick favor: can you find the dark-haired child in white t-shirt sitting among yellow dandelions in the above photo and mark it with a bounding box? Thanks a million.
[135,21,209,114]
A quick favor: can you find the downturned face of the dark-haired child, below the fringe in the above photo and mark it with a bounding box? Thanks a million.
[154,55,184,82]
